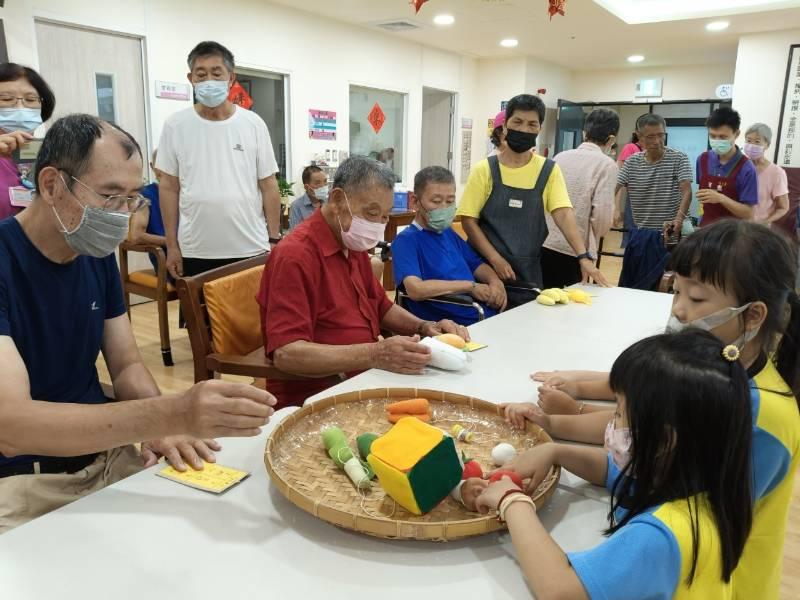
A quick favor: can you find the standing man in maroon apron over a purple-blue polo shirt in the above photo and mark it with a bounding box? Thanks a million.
[697,106,758,227]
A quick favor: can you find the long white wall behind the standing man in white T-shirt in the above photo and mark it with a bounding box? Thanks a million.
[0,0,478,192]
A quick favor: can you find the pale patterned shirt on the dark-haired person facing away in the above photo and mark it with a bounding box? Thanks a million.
[544,142,619,256]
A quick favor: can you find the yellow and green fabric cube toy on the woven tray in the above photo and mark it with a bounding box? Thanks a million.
[367,417,463,515]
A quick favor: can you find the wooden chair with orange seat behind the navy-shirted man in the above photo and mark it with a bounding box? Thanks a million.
[119,241,178,367]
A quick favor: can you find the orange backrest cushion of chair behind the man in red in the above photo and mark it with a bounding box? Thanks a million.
[203,266,264,356]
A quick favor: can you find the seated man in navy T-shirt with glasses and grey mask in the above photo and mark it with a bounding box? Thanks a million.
[0,115,275,533]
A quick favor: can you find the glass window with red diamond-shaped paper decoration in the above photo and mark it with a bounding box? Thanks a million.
[350,86,405,181]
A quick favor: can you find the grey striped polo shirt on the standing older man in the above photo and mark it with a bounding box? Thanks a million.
[617,148,693,231]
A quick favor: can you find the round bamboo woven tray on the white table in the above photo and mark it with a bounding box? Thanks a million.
[264,388,561,541]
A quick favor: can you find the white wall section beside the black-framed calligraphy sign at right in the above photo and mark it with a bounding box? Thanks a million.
[733,29,800,148]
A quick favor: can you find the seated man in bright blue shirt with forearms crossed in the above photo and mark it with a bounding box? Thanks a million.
[392,167,507,325]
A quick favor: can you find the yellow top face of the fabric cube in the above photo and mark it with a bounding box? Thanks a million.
[371,417,444,472]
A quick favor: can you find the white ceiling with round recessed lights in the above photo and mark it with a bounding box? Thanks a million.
[272,0,800,70]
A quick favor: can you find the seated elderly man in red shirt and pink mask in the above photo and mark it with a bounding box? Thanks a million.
[258,157,469,408]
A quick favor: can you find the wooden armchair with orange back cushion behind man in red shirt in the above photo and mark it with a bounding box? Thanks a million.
[177,254,305,382]
